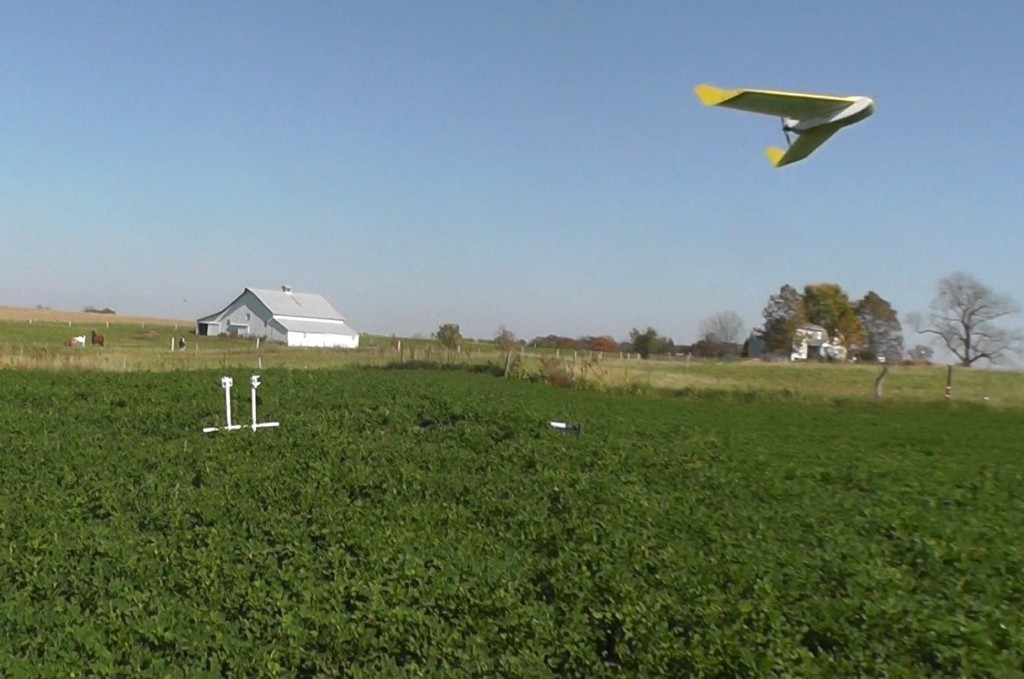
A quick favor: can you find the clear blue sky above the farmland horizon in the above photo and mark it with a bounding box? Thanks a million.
[0,0,1024,345]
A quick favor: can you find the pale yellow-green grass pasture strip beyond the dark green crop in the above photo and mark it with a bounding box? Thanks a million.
[0,307,1024,408]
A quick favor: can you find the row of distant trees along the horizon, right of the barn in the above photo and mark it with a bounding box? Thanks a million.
[434,272,1024,368]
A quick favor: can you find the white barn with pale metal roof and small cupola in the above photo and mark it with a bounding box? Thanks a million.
[196,286,359,349]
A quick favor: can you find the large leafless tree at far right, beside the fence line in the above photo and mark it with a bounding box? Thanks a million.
[907,272,1024,368]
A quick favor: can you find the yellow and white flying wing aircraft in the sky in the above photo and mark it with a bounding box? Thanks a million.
[693,85,874,167]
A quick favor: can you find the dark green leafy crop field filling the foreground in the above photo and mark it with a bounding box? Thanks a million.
[0,369,1024,677]
